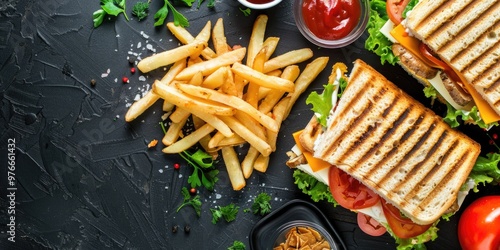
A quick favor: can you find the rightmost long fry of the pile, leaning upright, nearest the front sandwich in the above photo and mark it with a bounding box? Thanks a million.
[284,57,329,119]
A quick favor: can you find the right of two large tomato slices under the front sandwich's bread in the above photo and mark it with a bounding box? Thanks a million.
[382,202,432,239]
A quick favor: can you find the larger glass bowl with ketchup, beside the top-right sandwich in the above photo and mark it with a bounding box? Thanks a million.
[293,0,370,48]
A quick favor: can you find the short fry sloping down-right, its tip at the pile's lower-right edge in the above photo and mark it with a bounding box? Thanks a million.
[219,116,272,156]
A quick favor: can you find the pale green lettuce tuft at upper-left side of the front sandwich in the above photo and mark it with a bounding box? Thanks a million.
[306,84,335,127]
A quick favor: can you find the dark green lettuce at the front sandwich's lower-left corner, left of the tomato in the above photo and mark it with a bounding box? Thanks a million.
[293,169,338,207]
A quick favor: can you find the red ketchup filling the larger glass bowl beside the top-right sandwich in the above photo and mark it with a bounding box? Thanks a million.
[302,0,361,40]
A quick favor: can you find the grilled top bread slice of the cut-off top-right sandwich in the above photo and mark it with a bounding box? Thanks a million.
[406,0,500,114]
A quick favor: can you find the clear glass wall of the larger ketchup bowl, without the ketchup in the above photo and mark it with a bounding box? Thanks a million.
[293,0,370,48]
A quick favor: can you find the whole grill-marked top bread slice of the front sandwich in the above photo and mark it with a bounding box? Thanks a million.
[314,60,480,224]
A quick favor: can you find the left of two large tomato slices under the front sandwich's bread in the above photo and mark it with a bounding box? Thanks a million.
[328,166,380,209]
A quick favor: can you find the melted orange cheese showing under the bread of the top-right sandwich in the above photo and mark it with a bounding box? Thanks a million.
[390,24,500,124]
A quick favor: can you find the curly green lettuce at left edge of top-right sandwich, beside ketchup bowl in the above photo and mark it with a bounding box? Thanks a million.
[365,0,399,65]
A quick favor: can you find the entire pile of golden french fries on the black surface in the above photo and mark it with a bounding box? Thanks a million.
[125,15,328,190]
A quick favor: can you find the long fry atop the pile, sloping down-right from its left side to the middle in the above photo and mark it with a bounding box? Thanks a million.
[153,81,235,116]
